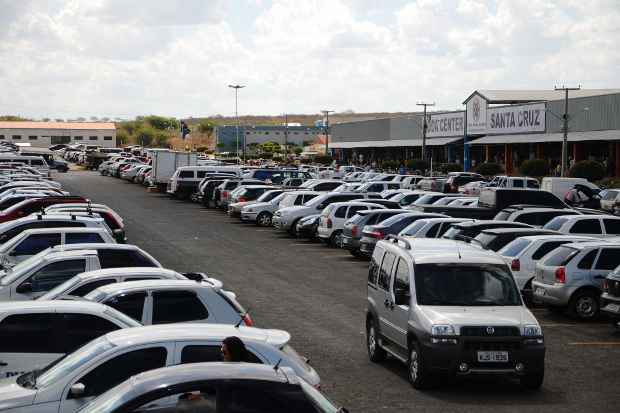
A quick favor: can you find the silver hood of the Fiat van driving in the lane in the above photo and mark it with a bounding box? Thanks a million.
[418,305,538,334]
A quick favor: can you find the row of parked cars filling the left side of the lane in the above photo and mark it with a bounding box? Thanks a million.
[0,157,339,412]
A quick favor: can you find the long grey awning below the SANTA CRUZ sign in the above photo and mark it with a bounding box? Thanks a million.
[468,129,620,145]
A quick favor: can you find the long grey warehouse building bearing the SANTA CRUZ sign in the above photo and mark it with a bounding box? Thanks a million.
[330,89,620,176]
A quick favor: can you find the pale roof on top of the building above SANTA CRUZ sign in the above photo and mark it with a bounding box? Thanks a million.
[463,89,620,104]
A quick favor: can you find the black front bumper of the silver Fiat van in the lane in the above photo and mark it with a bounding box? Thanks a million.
[420,337,545,376]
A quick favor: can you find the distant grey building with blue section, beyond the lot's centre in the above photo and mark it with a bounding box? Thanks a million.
[215,125,323,153]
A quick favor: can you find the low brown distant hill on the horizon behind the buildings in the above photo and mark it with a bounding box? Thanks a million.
[182,112,418,126]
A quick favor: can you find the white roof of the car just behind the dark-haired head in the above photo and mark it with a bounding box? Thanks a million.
[105,323,291,347]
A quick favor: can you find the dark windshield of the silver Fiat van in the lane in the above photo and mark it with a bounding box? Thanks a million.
[414,263,521,306]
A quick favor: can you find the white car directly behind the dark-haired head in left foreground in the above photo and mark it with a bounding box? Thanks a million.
[0,324,320,413]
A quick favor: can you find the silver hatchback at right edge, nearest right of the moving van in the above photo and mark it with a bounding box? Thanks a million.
[532,241,620,320]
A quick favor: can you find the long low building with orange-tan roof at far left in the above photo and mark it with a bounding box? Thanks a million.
[0,121,116,148]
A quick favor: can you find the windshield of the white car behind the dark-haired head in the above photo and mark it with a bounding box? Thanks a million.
[36,336,116,388]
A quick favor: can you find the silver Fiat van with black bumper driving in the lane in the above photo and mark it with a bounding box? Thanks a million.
[366,237,545,389]
